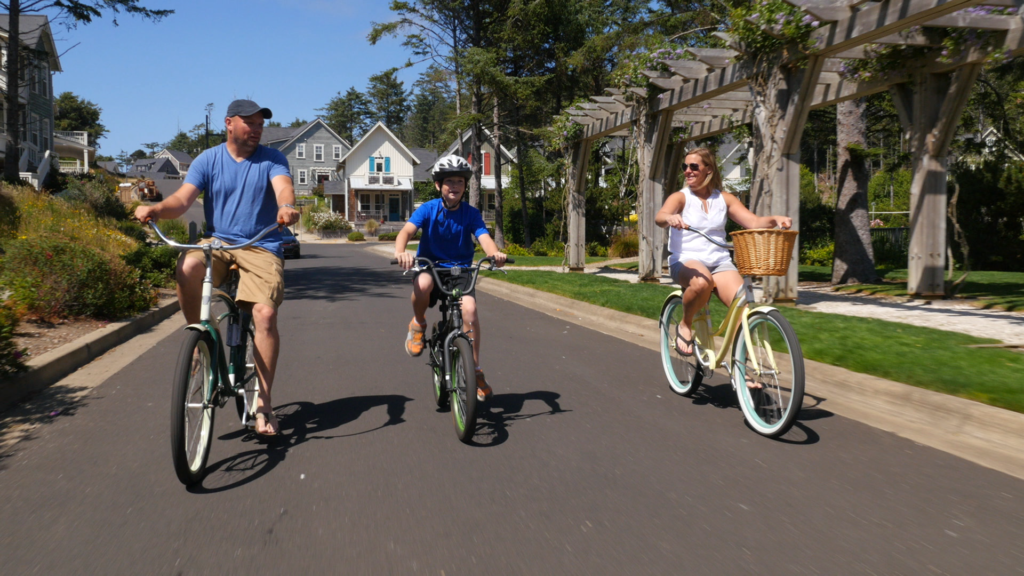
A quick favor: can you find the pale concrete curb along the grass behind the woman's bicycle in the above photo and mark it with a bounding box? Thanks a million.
[477,278,1024,479]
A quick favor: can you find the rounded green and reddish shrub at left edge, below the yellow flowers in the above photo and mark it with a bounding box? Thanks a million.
[0,237,156,320]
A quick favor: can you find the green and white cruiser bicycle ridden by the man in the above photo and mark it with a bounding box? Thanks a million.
[150,220,279,486]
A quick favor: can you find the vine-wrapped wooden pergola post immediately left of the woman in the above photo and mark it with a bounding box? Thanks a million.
[637,107,673,282]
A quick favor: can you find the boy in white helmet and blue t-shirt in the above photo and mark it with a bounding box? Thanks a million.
[394,156,506,401]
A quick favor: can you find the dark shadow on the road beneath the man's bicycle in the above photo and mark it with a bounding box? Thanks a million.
[187,395,413,494]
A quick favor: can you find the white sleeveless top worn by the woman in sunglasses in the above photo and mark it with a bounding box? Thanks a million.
[669,188,730,268]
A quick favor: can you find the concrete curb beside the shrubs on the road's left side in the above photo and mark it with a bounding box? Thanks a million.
[0,296,179,412]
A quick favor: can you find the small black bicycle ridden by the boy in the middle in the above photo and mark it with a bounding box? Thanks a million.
[391,256,515,442]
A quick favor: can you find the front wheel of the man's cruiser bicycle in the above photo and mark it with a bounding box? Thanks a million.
[171,330,217,486]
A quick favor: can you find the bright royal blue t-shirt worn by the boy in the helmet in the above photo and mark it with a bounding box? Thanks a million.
[409,198,488,268]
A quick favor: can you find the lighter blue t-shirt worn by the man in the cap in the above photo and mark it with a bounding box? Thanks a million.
[185,143,292,257]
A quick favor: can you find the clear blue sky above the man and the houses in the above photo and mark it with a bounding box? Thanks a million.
[53,0,425,156]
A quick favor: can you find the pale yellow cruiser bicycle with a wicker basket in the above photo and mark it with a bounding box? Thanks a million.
[659,228,804,438]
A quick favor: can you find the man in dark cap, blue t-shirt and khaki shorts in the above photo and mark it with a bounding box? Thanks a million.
[135,99,299,436]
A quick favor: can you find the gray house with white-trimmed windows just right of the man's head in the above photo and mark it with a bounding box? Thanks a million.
[260,118,352,195]
